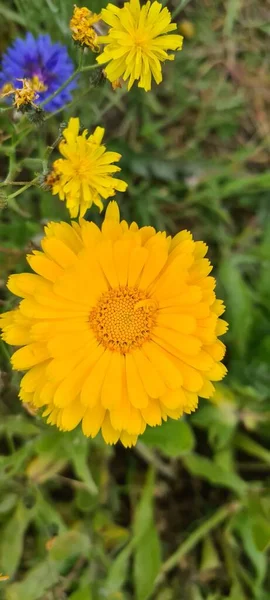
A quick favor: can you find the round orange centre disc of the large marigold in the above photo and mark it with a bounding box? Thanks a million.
[89,286,157,354]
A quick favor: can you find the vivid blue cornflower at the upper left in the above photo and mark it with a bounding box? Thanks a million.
[0,33,76,112]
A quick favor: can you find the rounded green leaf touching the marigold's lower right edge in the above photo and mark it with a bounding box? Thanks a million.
[141,419,194,458]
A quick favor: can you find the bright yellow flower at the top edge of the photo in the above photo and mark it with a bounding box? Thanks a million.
[97,0,183,92]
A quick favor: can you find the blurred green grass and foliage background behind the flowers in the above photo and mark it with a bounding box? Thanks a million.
[0,0,270,600]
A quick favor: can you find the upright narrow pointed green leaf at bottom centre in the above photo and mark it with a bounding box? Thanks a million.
[133,470,161,600]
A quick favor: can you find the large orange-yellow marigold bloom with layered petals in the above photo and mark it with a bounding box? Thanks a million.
[1,202,227,446]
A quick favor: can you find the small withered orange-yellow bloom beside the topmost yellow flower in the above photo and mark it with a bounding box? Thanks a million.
[70,4,100,52]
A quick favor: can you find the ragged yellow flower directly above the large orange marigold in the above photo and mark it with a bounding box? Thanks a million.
[51,118,127,217]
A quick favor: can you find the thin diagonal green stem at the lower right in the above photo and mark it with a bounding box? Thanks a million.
[155,502,239,586]
